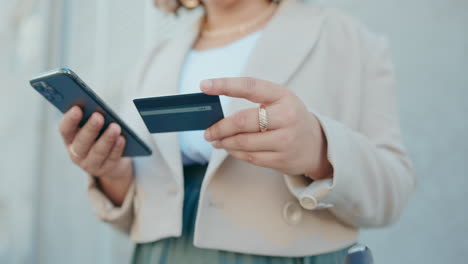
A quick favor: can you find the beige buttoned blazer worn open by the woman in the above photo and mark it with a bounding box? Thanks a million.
[89,1,415,256]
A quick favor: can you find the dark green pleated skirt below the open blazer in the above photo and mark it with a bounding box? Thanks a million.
[132,165,348,264]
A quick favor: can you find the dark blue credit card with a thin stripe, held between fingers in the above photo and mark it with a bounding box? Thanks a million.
[133,93,224,133]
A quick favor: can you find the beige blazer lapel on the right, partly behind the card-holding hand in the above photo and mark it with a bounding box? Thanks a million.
[205,0,323,182]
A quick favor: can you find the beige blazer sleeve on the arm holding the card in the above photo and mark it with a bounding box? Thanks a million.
[285,26,416,227]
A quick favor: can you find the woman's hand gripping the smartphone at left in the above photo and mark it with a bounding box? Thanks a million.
[60,106,133,205]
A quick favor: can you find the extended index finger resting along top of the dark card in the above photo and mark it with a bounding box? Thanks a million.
[200,77,287,104]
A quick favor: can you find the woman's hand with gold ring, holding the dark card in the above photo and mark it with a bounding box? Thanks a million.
[200,78,333,180]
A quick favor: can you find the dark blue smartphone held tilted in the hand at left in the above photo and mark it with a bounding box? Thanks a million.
[30,68,151,157]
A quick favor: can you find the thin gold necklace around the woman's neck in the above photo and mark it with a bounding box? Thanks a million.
[200,3,278,38]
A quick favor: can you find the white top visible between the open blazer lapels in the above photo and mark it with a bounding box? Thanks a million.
[179,31,261,165]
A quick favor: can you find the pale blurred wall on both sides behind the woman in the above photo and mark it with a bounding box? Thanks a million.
[0,0,468,264]
